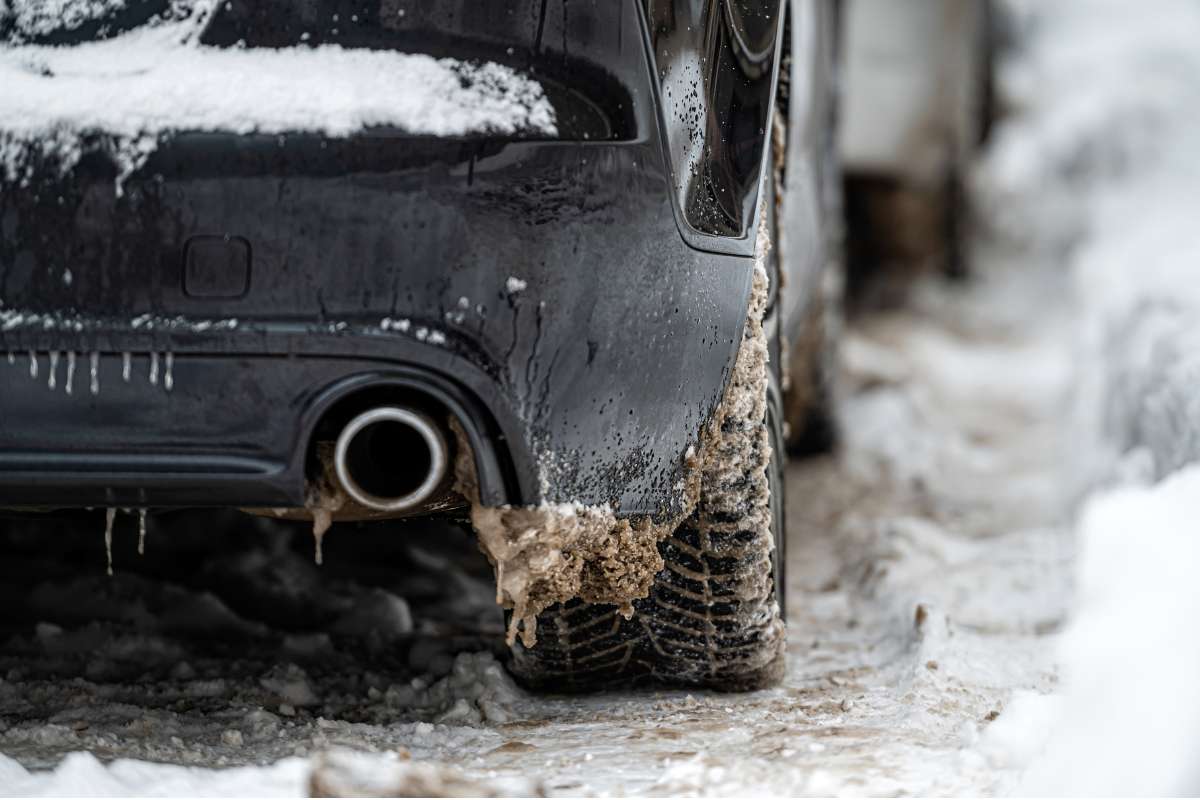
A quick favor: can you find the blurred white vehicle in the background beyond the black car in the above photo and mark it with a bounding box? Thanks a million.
[838,0,995,302]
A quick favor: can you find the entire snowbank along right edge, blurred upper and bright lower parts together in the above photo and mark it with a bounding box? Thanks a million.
[980,0,1200,795]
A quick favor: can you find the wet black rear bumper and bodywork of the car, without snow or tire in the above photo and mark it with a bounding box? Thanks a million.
[0,0,830,516]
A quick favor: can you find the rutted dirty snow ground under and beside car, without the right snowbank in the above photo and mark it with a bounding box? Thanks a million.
[0,244,1072,795]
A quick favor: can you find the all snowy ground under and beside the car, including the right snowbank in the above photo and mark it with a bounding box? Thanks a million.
[0,0,1200,796]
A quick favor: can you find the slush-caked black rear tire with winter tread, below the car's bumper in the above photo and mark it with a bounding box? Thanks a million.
[510,235,786,691]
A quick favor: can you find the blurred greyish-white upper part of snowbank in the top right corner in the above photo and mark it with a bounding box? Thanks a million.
[980,0,1200,486]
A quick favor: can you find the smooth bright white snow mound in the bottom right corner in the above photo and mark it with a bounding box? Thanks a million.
[1025,467,1200,795]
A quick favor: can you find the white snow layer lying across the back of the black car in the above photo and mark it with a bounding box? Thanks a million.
[0,0,556,179]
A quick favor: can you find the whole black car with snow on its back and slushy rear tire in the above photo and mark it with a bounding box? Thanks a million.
[0,0,839,688]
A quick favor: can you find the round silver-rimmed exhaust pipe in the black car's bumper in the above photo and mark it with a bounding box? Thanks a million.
[334,407,450,512]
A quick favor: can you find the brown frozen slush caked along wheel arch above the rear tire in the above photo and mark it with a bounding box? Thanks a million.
[455,217,782,648]
